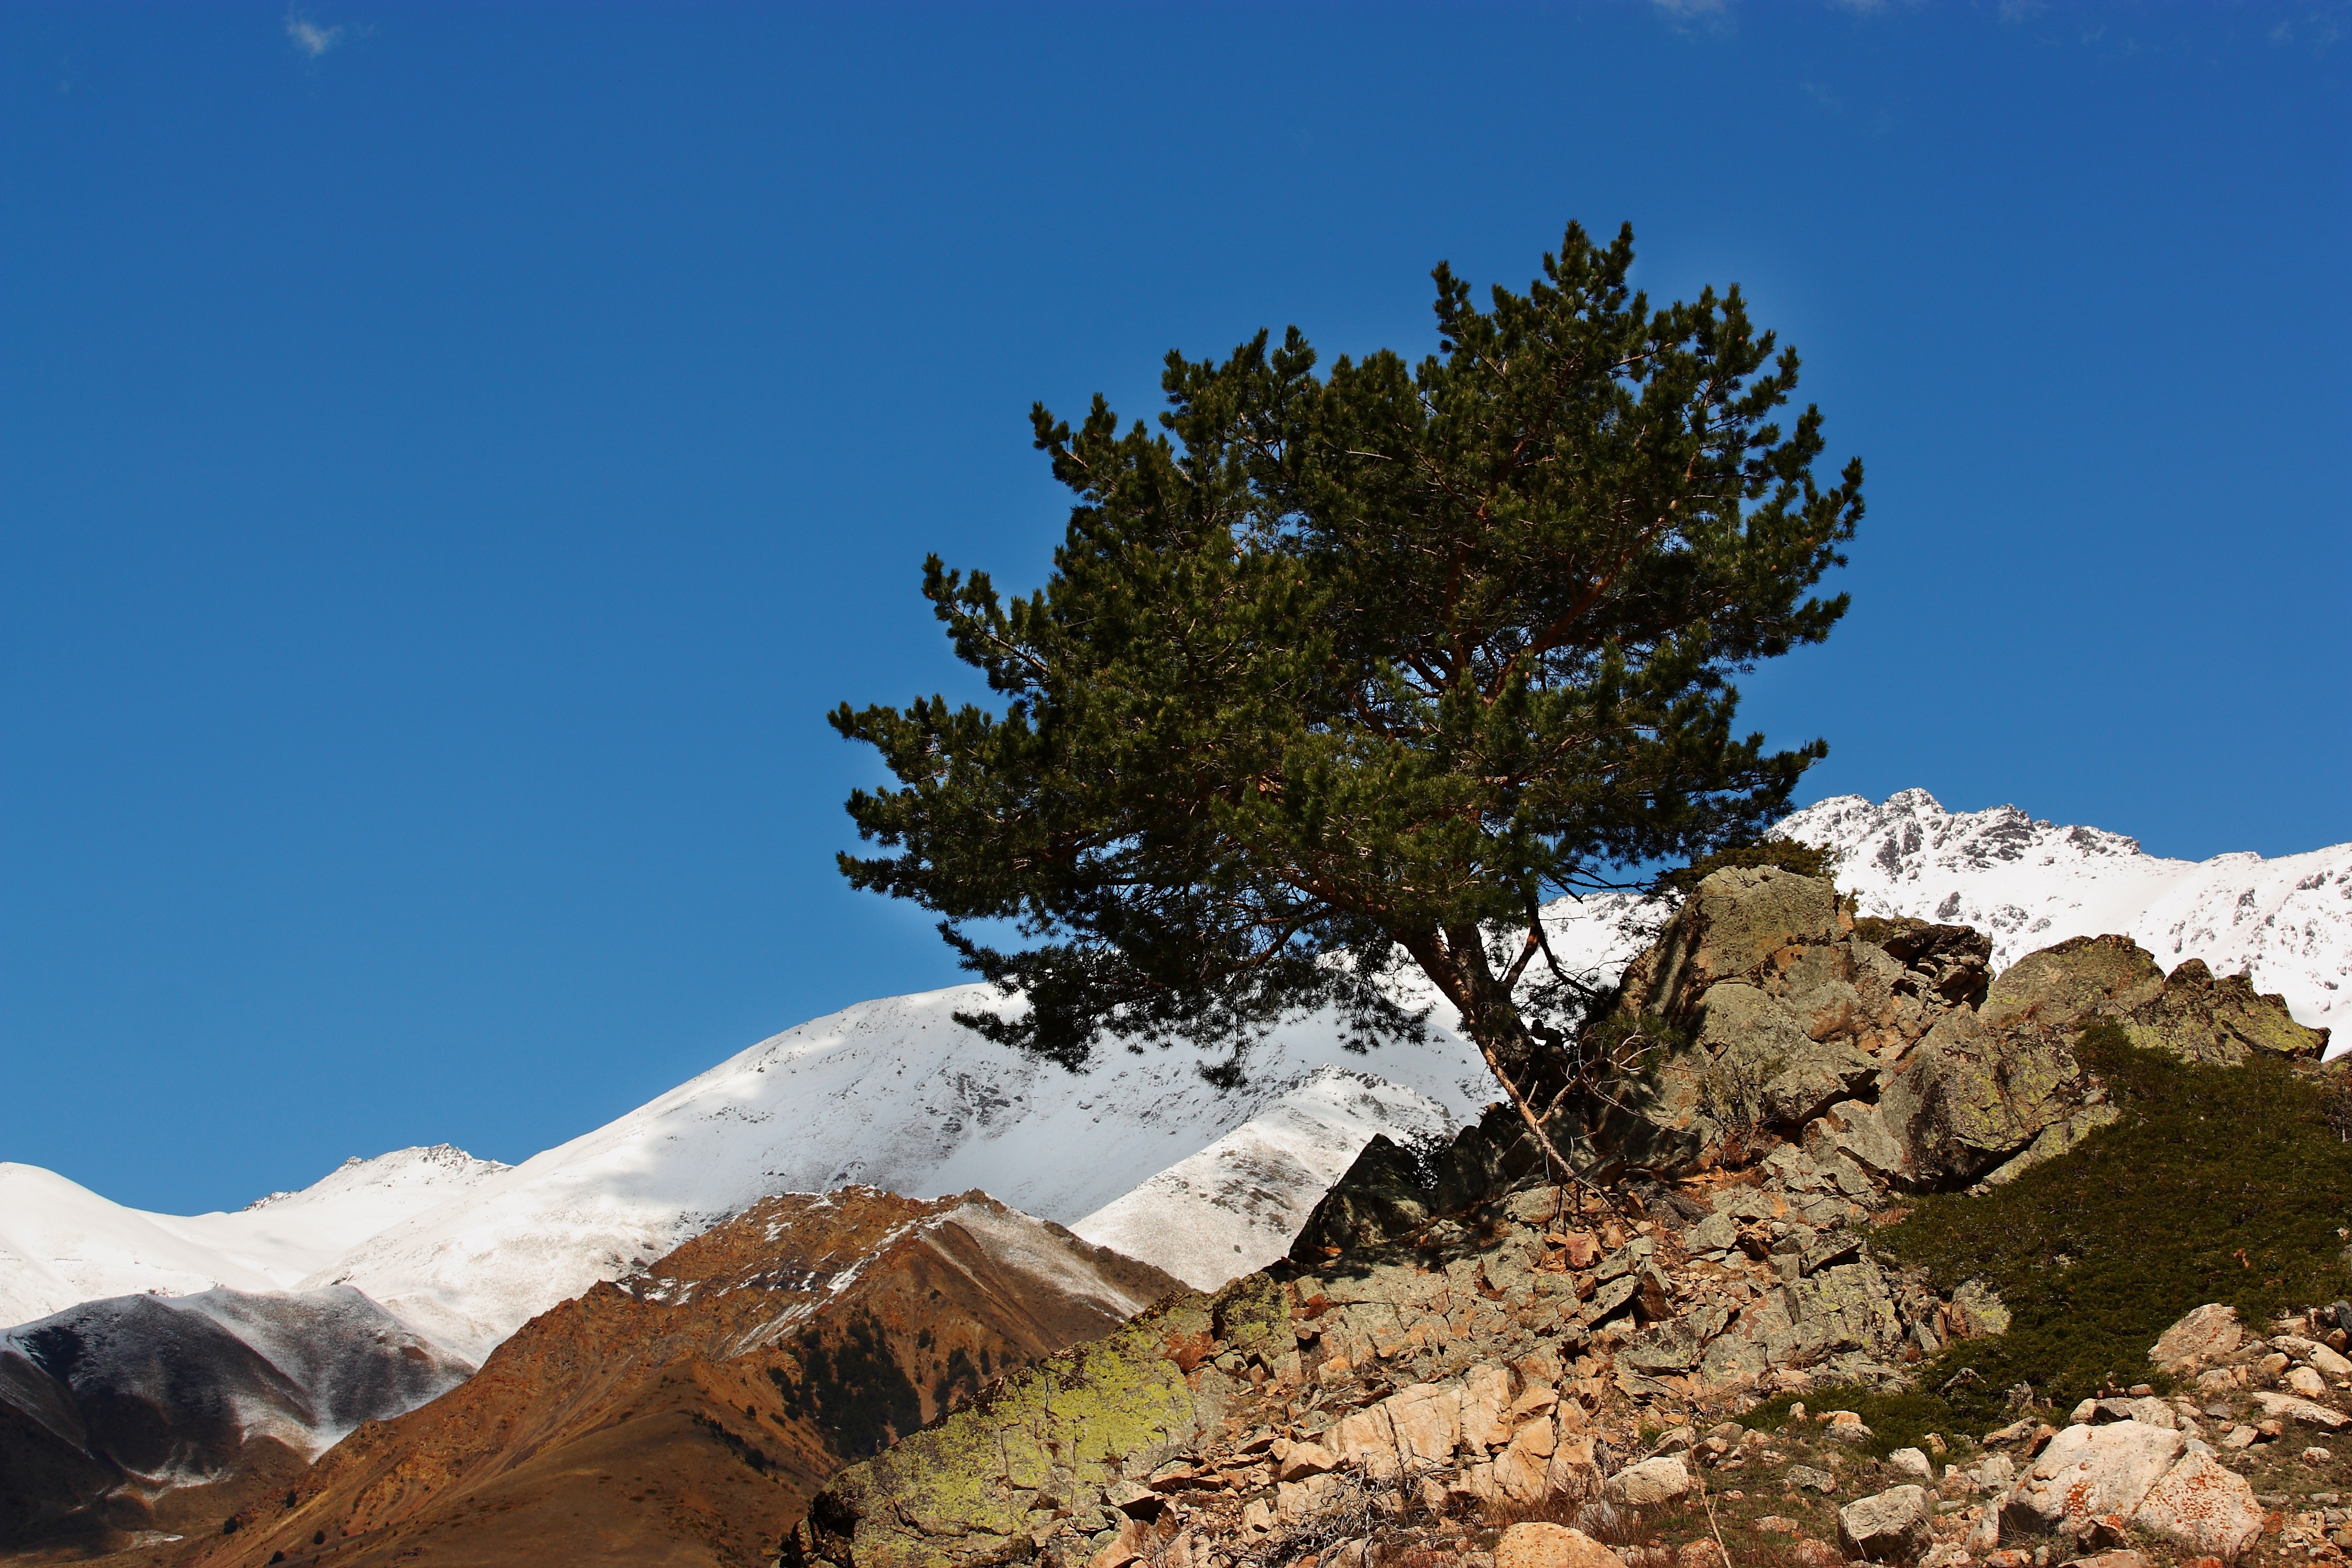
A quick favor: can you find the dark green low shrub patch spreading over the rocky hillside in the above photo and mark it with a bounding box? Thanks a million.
[1750,1025,2352,1451]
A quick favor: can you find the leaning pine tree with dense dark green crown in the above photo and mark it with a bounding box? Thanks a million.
[832,224,1863,1157]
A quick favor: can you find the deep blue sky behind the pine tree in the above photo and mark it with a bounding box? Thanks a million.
[0,0,2352,1211]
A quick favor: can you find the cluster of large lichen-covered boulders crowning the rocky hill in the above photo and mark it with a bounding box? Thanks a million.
[1373,868,2326,1204]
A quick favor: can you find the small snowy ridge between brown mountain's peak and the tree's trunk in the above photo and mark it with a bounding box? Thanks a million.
[1070,1068,1461,1291]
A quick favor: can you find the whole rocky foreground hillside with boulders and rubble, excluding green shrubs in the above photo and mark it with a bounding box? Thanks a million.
[783,870,2352,1568]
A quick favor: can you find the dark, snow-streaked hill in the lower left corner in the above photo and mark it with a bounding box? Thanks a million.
[0,1288,473,1549]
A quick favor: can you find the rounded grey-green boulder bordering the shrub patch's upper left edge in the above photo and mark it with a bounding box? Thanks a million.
[1879,1006,2084,1187]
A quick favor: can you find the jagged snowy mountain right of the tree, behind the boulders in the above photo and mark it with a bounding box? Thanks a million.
[1773,790,2352,1058]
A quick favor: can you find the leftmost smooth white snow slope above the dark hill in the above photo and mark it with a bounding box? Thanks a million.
[0,1145,505,1326]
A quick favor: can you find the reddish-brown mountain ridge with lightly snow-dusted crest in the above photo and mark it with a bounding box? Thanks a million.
[155,1187,1183,1568]
